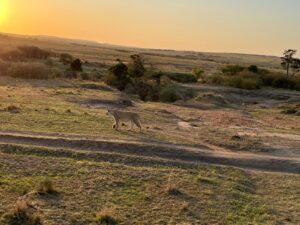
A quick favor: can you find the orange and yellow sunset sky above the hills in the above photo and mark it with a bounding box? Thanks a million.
[0,0,300,55]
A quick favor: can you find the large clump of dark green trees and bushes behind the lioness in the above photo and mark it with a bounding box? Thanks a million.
[104,55,201,102]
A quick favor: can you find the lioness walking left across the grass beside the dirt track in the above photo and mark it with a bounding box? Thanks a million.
[107,110,142,131]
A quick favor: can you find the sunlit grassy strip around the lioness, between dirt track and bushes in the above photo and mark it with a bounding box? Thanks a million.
[0,78,300,151]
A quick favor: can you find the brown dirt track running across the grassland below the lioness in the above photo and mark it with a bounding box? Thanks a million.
[0,131,300,174]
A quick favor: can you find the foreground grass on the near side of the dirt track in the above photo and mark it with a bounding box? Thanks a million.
[0,146,300,225]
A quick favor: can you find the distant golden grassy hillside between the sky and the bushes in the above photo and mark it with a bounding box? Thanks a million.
[0,32,281,73]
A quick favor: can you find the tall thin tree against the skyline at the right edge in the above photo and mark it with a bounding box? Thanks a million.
[281,49,300,78]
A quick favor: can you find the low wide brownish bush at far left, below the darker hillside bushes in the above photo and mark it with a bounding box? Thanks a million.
[7,62,54,79]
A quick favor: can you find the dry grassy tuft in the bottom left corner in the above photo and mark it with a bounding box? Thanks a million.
[0,200,42,225]
